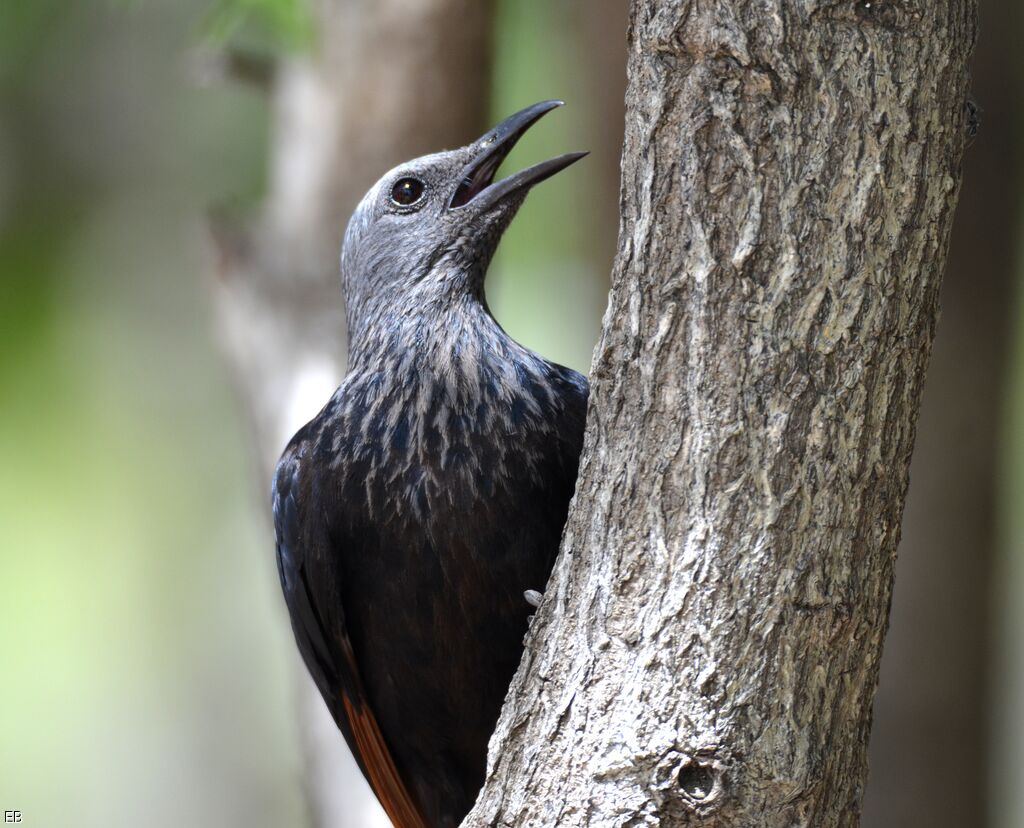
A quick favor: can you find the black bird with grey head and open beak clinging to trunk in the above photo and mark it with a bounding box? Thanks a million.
[271,100,589,828]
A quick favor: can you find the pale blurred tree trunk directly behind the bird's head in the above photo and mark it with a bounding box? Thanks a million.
[206,0,492,828]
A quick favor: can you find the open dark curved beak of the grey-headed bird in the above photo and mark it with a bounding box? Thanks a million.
[449,100,587,211]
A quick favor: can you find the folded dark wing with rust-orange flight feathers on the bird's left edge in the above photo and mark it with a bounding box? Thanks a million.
[272,440,428,828]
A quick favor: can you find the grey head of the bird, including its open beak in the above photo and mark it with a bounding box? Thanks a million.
[341,100,587,345]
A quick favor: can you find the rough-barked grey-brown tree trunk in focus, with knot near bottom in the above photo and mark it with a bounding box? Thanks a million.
[465,0,975,828]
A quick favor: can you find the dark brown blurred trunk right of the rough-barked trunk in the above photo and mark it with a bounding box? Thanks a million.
[864,0,1024,828]
